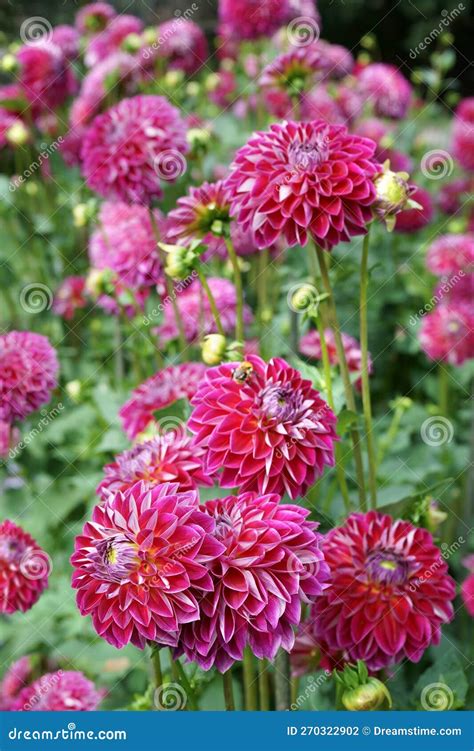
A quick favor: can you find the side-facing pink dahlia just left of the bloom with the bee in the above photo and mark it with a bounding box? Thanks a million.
[119,362,207,440]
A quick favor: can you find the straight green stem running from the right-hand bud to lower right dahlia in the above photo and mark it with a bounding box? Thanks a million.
[360,232,377,508]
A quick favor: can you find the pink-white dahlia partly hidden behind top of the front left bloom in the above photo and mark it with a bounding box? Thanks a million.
[97,430,212,501]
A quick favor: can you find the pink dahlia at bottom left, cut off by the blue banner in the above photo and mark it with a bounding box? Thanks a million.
[11,670,105,712]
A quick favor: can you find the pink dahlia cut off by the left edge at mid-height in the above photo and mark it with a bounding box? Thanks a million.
[0,331,59,422]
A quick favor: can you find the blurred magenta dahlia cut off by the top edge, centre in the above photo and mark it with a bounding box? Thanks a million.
[219,0,291,40]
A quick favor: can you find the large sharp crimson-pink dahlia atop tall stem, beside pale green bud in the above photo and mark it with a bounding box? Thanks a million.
[227,120,380,250]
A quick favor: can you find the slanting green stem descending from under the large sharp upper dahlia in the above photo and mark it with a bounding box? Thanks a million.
[315,245,367,511]
